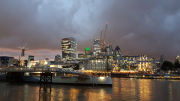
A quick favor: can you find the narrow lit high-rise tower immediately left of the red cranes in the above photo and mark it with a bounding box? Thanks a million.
[93,39,101,55]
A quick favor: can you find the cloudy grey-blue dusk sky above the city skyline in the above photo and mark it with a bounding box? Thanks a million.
[0,0,180,61]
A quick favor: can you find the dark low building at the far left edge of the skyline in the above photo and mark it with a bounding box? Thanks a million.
[0,56,14,67]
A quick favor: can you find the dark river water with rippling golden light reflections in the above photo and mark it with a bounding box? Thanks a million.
[0,78,180,101]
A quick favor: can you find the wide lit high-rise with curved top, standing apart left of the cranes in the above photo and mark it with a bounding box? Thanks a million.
[61,37,77,61]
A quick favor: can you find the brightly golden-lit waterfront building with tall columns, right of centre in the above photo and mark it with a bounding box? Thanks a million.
[136,55,156,72]
